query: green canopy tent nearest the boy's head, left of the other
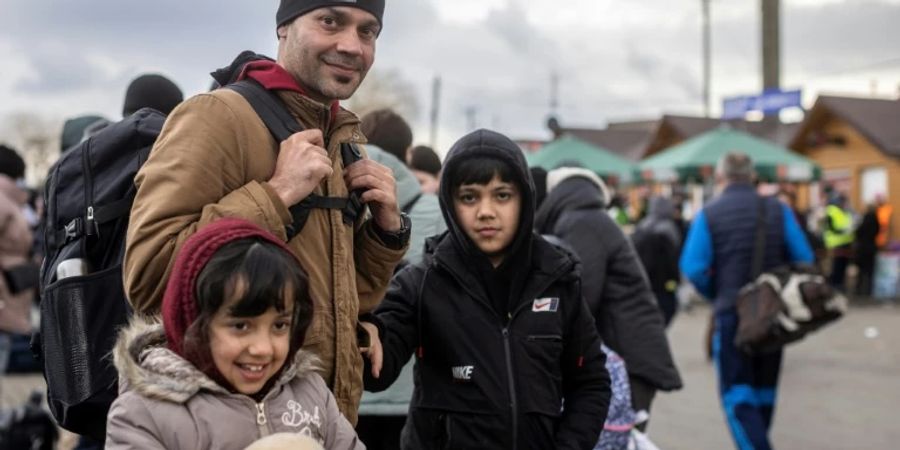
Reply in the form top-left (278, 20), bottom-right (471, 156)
top-left (526, 136), bottom-right (637, 184)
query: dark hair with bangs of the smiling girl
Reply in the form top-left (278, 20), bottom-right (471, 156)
top-left (184, 237), bottom-right (313, 378)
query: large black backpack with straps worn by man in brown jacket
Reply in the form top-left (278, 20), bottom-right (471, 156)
top-left (32, 60), bottom-right (364, 441)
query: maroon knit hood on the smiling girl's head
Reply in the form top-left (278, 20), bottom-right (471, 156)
top-left (162, 218), bottom-right (299, 356)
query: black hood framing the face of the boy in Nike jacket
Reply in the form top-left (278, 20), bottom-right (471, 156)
top-left (438, 126), bottom-right (535, 274)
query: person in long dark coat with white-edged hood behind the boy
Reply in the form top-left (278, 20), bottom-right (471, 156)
top-left (535, 168), bottom-right (681, 425)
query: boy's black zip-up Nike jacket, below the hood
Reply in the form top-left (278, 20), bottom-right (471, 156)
top-left (365, 234), bottom-right (610, 450)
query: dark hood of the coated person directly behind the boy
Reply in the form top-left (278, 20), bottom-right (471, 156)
top-left (534, 177), bottom-right (606, 234)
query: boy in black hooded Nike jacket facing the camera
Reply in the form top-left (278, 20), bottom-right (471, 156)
top-left (365, 130), bottom-right (610, 450)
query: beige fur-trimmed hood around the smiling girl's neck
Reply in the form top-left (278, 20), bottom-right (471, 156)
top-left (113, 316), bottom-right (318, 404)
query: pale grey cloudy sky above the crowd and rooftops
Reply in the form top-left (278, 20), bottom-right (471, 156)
top-left (0, 0), bottom-right (900, 150)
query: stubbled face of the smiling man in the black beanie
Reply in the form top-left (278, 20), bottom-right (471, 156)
top-left (278, 6), bottom-right (380, 104)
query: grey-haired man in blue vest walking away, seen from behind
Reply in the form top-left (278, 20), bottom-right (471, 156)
top-left (680, 152), bottom-right (813, 450)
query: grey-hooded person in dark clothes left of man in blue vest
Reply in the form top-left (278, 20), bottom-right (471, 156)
top-left (631, 197), bottom-right (681, 327)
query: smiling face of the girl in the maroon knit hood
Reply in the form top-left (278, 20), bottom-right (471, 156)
top-left (209, 283), bottom-right (293, 395)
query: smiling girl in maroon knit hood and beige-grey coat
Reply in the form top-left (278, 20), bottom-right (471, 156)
top-left (106, 219), bottom-right (365, 450)
